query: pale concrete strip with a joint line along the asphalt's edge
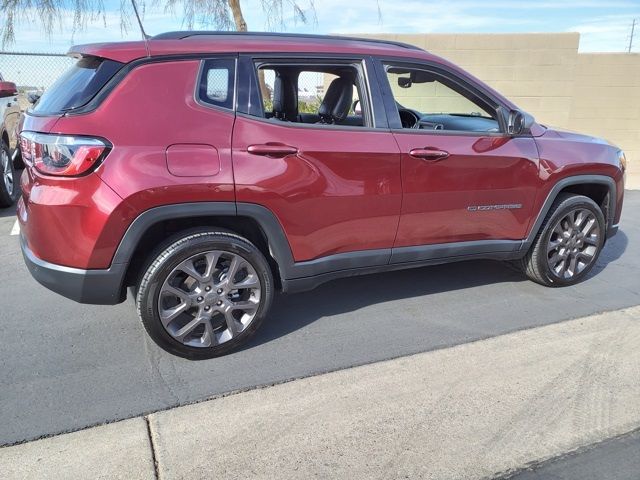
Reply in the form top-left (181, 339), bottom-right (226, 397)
top-left (0, 307), bottom-right (640, 479)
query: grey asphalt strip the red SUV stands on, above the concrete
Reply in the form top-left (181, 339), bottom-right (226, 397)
top-left (0, 191), bottom-right (640, 445)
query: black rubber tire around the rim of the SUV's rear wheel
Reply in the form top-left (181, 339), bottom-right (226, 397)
top-left (136, 230), bottom-right (274, 360)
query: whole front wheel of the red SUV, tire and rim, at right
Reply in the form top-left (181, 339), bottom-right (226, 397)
top-left (521, 194), bottom-right (606, 287)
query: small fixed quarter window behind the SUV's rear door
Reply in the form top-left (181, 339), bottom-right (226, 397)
top-left (198, 58), bottom-right (236, 109)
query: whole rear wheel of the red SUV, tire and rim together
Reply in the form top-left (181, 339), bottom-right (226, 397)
top-left (136, 231), bottom-right (273, 359)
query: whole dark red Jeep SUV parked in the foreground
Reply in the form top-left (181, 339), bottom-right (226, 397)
top-left (18, 32), bottom-right (625, 358)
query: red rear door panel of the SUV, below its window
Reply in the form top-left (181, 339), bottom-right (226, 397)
top-left (233, 116), bottom-right (402, 261)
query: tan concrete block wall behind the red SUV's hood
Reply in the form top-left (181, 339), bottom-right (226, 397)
top-left (358, 33), bottom-right (640, 184)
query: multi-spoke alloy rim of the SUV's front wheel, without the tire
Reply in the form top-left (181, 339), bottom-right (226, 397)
top-left (547, 208), bottom-right (601, 280)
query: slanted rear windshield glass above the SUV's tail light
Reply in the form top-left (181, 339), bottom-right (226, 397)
top-left (32, 57), bottom-right (124, 115)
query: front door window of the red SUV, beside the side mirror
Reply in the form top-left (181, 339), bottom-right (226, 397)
top-left (385, 65), bottom-right (500, 132)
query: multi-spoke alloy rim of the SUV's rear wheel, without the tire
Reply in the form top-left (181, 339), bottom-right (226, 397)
top-left (158, 250), bottom-right (261, 347)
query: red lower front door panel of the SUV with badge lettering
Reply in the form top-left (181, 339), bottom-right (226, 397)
top-left (394, 131), bottom-right (540, 247)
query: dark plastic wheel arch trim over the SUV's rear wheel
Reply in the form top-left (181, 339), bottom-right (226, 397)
top-left (118, 202), bottom-right (293, 288)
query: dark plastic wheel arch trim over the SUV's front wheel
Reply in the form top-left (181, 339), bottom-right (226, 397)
top-left (523, 175), bottom-right (617, 251)
